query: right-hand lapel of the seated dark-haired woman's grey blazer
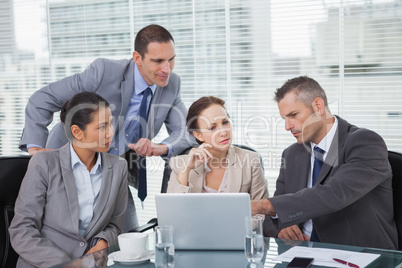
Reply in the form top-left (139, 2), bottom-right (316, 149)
top-left (85, 153), bottom-right (113, 236)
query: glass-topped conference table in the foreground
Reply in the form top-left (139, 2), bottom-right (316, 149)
top-left (55, 238), bottom-right (402, 268)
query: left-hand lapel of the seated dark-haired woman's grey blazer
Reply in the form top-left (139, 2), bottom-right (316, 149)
top-left (59, 143), bottom-right (79, 233)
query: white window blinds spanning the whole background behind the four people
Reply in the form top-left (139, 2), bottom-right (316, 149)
top-left (0, 0), bottom-right (402, 253)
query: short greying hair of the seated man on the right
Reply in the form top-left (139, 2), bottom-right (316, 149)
top-left (274, 76), bottom-right (328, 107)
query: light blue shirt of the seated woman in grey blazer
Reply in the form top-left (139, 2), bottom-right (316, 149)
top-left (70, 143), bottom-right (102, 235)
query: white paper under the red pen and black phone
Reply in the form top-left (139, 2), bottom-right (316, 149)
top-left (274, 246), bottom-right (380, 268)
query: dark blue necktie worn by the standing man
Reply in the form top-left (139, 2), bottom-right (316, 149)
top-left (137, 87), bottom-right (152, 201)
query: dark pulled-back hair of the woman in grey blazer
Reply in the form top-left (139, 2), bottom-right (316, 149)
top-left (60, 92), bottom-right (110, 141)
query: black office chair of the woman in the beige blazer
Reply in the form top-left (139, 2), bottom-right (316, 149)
top-left (129, 144), bottom-right (264, 232)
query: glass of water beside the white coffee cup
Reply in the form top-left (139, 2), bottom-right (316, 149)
top-left (155, 225), bottom-right (174, 268)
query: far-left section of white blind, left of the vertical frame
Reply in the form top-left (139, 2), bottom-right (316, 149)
top-left (0, 0), bottom-right (49, 155)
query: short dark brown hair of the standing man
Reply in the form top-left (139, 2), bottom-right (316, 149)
top-left (134, 24), bottom-right (174, 57)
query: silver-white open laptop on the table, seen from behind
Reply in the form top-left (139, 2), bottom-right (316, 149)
top-left (155, 193), bottom-right (251, 250)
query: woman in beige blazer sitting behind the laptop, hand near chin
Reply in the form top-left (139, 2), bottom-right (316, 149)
top-left (167, 96), bottom-right (268, 199)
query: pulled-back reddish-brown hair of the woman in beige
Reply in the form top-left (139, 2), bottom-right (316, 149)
top-left (186, 96), bottom-right (226, 144)
